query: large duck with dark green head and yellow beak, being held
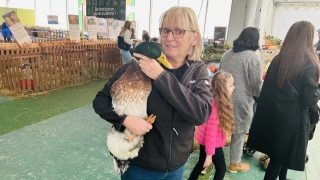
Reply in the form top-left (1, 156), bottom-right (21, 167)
top-left (107, 42), bottom-right (172, 174)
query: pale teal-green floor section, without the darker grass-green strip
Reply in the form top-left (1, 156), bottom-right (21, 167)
top-left (0, 104), bottom-right (314, 180)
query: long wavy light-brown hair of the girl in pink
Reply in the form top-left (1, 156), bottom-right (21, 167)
top-left (211, 70), bottom-right (235, 135)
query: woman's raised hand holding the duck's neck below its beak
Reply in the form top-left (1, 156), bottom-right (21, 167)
top-left (133, 53), bottom-right (164, 80)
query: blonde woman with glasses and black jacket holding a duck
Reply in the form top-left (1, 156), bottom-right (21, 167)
top-left (93, 7), bottom-right (212, 180)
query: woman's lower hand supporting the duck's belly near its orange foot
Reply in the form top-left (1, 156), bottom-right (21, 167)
top-left (122, 116), bottom-right (152, 136)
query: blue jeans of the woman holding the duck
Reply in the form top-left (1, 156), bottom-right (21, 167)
top-left (121, 165), bottom-right (184, 180)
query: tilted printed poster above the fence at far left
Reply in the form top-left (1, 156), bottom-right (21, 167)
top-left (2, 11), bottom-right (32, 47)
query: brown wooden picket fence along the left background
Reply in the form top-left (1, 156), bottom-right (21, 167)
top-left (0, 41), bottom-right (121, 94)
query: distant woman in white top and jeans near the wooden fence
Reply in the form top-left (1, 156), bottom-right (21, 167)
top-left (119, 21), bottom-right (133, 64)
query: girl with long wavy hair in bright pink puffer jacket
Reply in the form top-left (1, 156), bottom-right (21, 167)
top-left (189, 71), bottom-right (235, 180)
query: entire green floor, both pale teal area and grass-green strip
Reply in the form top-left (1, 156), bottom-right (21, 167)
top-left (0, 80), bottom-right (320, 180)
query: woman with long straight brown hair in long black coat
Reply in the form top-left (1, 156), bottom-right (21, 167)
top-left (247, 21), bottom-right (320, 180)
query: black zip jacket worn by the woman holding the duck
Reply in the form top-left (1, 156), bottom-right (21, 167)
top-left (93, 60), bottom-right (212, 171)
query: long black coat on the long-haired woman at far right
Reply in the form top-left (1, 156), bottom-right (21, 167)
top-left (247, 57), bottom-right (320, 171)
